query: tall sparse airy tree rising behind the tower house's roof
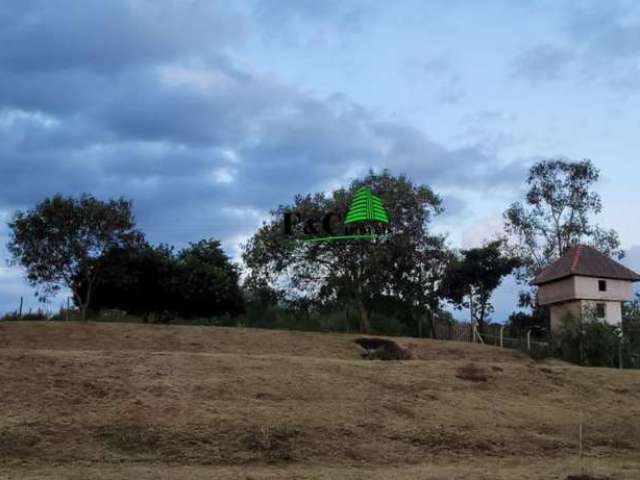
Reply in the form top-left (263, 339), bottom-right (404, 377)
top-left (504, 159), bottom-right (623, 306)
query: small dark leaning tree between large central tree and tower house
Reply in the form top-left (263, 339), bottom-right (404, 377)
top-left (442, 240), bottom-right (520, 332)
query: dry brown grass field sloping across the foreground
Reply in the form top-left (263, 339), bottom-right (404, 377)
top-left (0, 322), bottom-right (640, 480)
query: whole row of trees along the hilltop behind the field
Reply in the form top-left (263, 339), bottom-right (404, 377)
top-left (8, 159), bottom-right (622, 336)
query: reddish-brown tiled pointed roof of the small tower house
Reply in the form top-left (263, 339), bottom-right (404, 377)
top-left (531, 245), bottom-right (640, 285)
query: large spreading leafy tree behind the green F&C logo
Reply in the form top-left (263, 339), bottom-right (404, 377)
top-left (243, 171), bottom-right (441, 332)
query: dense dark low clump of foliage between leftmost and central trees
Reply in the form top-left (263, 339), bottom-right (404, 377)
top-left (74, 240), bottom-right (243, 325)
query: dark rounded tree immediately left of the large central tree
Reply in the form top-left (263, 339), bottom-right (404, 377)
top-left (177, 240), bottom-right (244, 317)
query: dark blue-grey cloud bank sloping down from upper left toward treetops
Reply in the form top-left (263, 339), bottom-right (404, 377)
top-left (0, 1), bottom-right (522, 309)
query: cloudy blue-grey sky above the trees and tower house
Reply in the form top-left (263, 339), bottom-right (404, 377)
top-left (0, 0), bottom-right (640, 321)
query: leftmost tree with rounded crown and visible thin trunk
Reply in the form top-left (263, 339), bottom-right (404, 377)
top-left (8, 194), bottom-right (141, 320)
